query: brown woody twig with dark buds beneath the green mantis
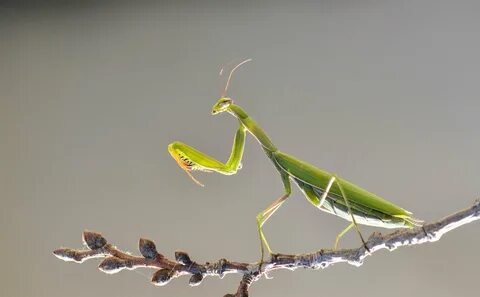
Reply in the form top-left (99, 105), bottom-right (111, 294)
top-left (53, 200), bottom-right (480, 297)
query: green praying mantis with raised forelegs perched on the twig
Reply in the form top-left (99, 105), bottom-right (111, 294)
top-left (168, 59), bottom-right (422, 262)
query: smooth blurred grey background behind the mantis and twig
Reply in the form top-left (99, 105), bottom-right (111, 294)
top-left (0, 0), bottom-right (480, 297)
